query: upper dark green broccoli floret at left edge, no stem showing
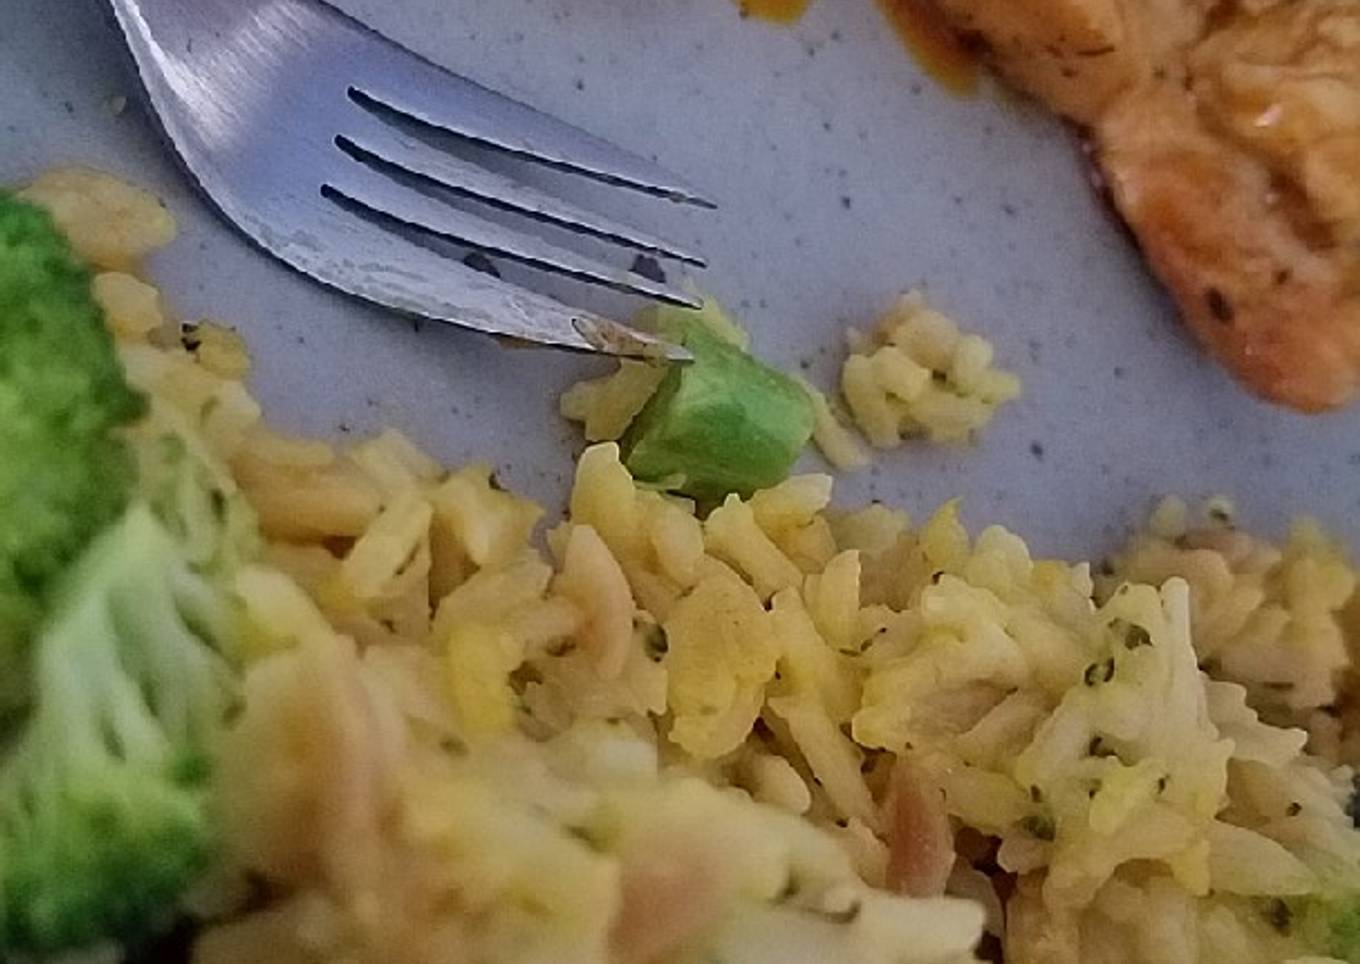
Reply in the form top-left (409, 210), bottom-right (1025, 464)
top-left (0, 192), bottom-right (144, 711)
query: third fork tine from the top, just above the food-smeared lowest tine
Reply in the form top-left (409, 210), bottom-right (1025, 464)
top-left (325, 162), bottom-right (702, 307)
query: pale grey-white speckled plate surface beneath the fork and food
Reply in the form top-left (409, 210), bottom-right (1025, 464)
top-left (0, 0), bottom-right (1360, 553)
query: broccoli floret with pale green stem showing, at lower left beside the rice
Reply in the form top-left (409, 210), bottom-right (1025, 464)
top-left (0, 503), bottom-right (237, 957)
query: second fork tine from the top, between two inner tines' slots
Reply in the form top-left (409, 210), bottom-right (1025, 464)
top-left (337, 111), bottom-right (704, 266)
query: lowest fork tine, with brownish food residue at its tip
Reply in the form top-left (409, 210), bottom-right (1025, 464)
top-left (294, 209), bottom-right (692, 362)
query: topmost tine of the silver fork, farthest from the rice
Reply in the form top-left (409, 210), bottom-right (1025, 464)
top-left (340, 22), bottom-right (715, 208)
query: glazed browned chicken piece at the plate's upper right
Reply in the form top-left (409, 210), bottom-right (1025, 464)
top-left (937, 0), bottom-right (1360, 412)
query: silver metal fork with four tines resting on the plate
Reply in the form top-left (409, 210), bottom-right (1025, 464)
top-left (109, 0), bottom-right (713, 360)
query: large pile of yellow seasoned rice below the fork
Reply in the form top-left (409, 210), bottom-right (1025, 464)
top-left (23, 165), bottom-right (1360, 964)
